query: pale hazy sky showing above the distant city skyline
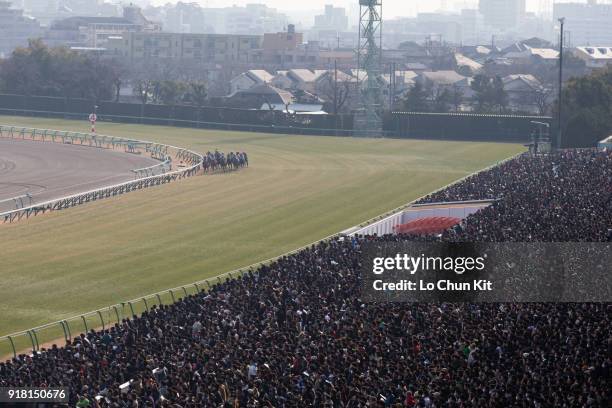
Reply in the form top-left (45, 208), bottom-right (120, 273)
top-left (153, 0), bottom-right (552, 17)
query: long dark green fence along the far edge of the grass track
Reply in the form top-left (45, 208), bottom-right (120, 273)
top-left (0, 94), bottom-right (552, 142)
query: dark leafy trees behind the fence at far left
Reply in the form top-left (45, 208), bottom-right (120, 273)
top-left (0, 39), bottom-right (208, 106)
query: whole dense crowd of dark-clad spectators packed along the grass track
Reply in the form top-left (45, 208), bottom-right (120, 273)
top-left (0, 152), bottom-right (612, 407)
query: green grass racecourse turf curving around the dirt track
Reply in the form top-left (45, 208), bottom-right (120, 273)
top-left (0, 116), bottom-right (523, 342)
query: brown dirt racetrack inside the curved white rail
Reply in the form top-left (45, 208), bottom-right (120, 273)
top-left (0, 139), bottom-right (159, 212)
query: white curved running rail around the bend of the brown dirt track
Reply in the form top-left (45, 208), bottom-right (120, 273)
top-left (0, 125), bottom-right (204, 223)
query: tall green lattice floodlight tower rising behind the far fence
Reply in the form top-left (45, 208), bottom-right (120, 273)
top-left (354, 0), bottom-right (382, 136)
